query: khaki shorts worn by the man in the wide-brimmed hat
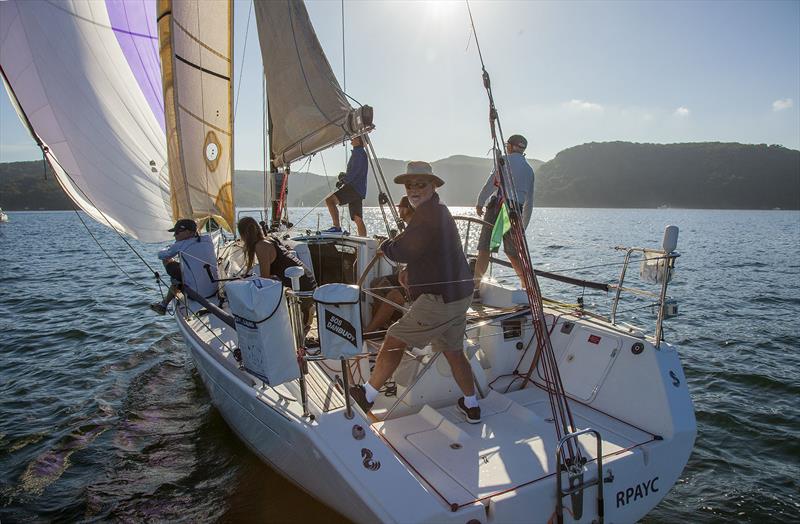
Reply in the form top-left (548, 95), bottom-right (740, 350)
top-left (386, 293), bottom-right (472, 351)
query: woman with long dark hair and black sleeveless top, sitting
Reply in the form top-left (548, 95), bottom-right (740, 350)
top-left (236, 217), bottom-right (317, 331)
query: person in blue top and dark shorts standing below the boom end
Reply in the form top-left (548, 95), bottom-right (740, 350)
top-left (325, 136), bottom-right (369, 237)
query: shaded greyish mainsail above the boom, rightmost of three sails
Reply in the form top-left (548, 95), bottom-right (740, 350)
top-left (255, 0), bottom-right (372, 167)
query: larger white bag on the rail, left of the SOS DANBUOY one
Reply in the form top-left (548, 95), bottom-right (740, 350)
top-left (225, 278), bottom-right (300, 386)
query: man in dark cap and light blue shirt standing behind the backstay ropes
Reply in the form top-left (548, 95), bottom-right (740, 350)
top-left (475, 135), bottom-right (534, 289)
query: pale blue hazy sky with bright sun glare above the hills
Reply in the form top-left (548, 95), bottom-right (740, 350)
top-left (0, 0), bottom-right (800, 175)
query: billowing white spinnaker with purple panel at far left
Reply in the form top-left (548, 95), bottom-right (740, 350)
top-left (0, 0), bottom-right (172, 242)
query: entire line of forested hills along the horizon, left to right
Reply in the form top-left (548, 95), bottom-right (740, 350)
top-left (0, 142), bottom-right (800, 210)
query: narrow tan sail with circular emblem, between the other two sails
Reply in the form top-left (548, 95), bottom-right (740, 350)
top-left (158, 0), bottom-right (234, 231)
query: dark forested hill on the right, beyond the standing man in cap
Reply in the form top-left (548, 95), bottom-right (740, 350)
top-left (536, 142), bottom-right (800, 209)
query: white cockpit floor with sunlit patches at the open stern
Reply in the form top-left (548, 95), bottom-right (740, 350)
top-left (373, 387), bottom-right (653, 506)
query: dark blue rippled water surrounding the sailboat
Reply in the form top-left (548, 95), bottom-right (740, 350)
top-left (0, 209), bottom-right (800, 523)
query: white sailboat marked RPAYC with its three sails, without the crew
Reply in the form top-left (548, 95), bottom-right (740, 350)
top-left (0, 0), bottom-right (696, 523)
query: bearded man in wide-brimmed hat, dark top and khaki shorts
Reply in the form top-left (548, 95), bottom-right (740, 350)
top-left (350, 161), bottom-right (481, 424)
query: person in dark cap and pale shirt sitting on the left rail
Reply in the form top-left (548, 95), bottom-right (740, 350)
top-left (150, 218), bottom-right (219, 315)
